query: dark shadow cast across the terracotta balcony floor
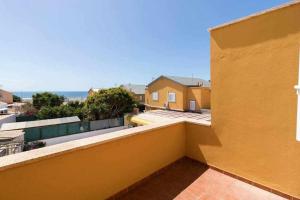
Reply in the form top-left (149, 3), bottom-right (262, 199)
top-left (118, 158), bottom-right (208, 200)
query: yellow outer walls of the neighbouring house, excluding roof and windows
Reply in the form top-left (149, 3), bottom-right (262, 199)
top-left (145, 78), bottom-right (210, 111)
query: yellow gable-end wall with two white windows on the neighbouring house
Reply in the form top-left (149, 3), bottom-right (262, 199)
top-left (145, 78), bottom-right (187, 111)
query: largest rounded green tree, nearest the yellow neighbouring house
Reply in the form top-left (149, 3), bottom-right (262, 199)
top-left (85, 87), bottom-right (136, 120)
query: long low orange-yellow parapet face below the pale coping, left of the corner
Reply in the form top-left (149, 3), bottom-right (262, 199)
top-left (0, 123), bottom-right (185, 200)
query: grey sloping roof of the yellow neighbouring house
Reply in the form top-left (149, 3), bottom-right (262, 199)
top-left (148, 76), bottom-right (210, 87)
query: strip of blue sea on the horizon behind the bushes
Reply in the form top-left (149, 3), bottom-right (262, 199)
top-left (13, 91), bottom-right (88, 101)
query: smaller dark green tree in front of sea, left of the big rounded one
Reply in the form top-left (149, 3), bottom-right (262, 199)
top-left (32, 92), bottom-right (65, 110)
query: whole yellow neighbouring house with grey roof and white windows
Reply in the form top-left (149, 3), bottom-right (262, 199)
top-left (145, 76), bottom-right (210, 112)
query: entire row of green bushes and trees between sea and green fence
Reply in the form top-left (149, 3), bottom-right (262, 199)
top-left (33, 87), bottom-right (137, 120)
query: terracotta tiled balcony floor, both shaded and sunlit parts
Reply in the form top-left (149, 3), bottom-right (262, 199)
top-left (118, 158), bottom-right (285, 200)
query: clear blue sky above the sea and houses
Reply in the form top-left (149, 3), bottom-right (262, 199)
top-left (0, 0), bottom-right (288, 91)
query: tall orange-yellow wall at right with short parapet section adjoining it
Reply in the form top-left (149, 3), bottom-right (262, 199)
top-left (187, 4), bottom-right (300, 197)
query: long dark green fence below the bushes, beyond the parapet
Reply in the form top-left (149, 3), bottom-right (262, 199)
top-left (24, 118), bottom-right (124, 142)
